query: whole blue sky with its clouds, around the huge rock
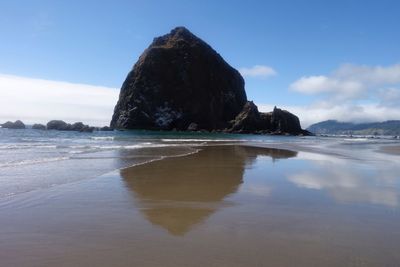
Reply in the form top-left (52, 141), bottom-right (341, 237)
top-left (0, 0), bottom-right (400, 127)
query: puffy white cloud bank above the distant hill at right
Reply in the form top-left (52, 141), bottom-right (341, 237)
top-left (259, 64), bottom-right (400, 127)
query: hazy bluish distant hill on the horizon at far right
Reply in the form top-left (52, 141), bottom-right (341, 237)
top-left (307, 120), bottom-right (400, 135)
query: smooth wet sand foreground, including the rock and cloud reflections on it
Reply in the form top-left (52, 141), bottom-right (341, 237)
top-left (0, 146), bottom-right (400, 267)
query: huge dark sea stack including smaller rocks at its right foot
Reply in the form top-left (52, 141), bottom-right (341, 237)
top-left (111, 27), bottom-right (305, 134)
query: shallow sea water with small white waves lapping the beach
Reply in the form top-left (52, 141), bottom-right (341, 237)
top-left (0, 128), bottom-right (399, 199)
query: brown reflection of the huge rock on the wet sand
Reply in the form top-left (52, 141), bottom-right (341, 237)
top-left (121, 146), bottom-right (296, 235)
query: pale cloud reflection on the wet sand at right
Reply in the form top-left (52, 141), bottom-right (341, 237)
top-left (288, 162), bottom-right (399, 207)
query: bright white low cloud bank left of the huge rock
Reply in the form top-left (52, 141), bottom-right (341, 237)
top-left (0, 74), bottom-right (119, 126)
